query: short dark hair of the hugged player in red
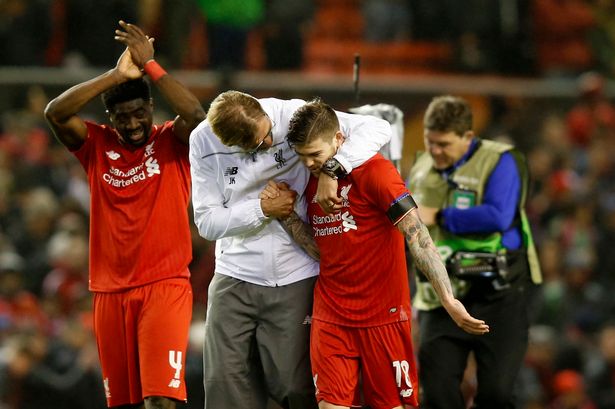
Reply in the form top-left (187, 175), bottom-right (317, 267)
top-left (286, 98), bottom-right (340, 147)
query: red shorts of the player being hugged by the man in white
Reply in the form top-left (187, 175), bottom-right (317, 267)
top-left (310, 320), bottom-right (419, 409)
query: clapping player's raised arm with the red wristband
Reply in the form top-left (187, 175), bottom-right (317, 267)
top-left (115, 21), bottom-right (205, 144)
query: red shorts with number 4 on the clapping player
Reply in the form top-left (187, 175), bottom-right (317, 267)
top-left (94, 278), bottom-right (192, 406)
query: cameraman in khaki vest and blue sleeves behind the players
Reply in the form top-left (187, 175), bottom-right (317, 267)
top-left (409, 95), bottom-right (541, 409)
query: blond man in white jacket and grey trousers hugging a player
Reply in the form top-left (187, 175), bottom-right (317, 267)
top-left (190, 91), bottom-right (391, 409)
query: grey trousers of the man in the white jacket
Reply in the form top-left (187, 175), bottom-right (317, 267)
top-left (203, 274), bottom-right (318, 409)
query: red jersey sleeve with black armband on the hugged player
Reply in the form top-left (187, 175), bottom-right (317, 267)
top-left (364, 155), bottom-right (417, 224)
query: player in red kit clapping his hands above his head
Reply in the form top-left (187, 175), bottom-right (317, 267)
top-left (45, 21), bottom-right (205, 409)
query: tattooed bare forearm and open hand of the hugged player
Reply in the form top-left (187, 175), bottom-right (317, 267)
top-left (397, 208), bottom-right (489, 335)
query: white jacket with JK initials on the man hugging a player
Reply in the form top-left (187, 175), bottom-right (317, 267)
top-left (190, 98), bottom-right (391, 286)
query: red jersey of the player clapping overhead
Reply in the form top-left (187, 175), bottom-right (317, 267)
top-left (74, 121), bottom-right (192, 292)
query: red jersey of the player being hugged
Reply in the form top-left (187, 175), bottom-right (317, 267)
top-left (306, 155), bottom-right (411, 327)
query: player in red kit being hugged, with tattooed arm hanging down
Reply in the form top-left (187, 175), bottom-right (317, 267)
top-left (262, 100), bottom-right (489, 409)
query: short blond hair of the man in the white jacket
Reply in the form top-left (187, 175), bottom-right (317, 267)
top-left (207, 91), bottom-right (266, 149)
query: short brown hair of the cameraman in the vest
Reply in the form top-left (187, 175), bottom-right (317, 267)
top-left (423, 95), bottom-right (472, 136)
